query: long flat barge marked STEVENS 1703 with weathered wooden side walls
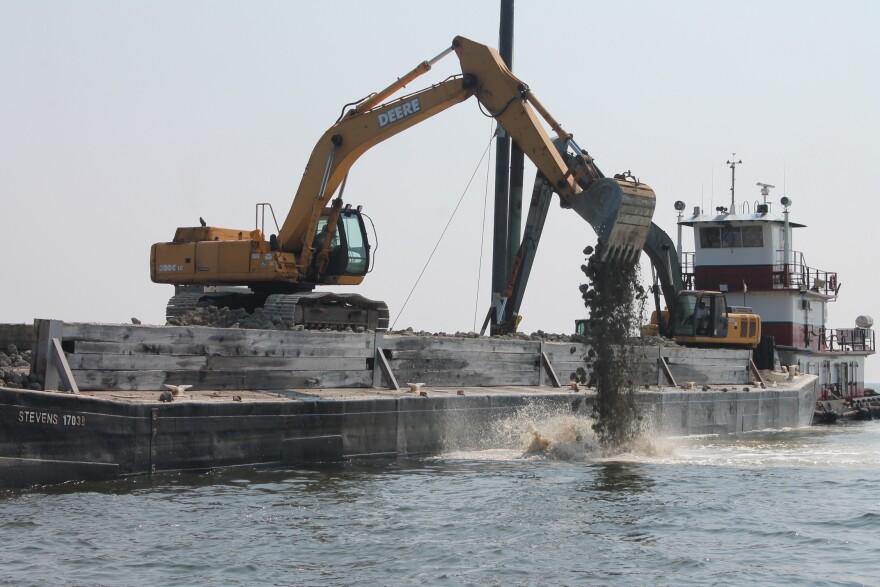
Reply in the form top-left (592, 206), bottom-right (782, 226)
top-left (0, 321), bottom-right (818, 486)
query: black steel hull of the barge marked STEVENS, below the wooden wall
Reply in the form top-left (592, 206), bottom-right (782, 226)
top-left (0, 375), bottom-right (818, 487)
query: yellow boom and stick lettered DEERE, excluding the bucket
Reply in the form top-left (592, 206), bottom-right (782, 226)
top-left (278, 36), bottom-right (636, 272)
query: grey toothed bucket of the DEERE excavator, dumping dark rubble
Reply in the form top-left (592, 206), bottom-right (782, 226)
top-left (566, 177), bottom-right (656, 263)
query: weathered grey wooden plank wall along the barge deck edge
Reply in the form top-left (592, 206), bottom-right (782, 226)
top-left (27, 320), bottom-right (750, 391)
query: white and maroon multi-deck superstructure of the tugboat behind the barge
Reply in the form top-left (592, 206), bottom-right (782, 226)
top-left (678, 184), bottom-right (876, 400)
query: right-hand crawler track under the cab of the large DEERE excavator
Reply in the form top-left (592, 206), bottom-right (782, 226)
top-left (263, 292), bottom-right (389, 330)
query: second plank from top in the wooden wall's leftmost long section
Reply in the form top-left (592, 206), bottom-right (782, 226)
top-left (72, 340), bottom-right (373, 359)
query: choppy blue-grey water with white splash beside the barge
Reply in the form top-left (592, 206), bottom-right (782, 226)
top-left (0, 406), bottom-right (880, 586)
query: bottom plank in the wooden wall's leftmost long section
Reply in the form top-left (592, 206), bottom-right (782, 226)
top-left (73, 370), bottom-right (372, 397)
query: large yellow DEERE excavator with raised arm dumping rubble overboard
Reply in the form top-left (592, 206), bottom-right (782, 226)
top-left (150, 36), bottom-right (655, 330)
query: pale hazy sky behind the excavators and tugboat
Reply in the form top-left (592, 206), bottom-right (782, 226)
top-left (0, 0), bottom-right (880, 381)
